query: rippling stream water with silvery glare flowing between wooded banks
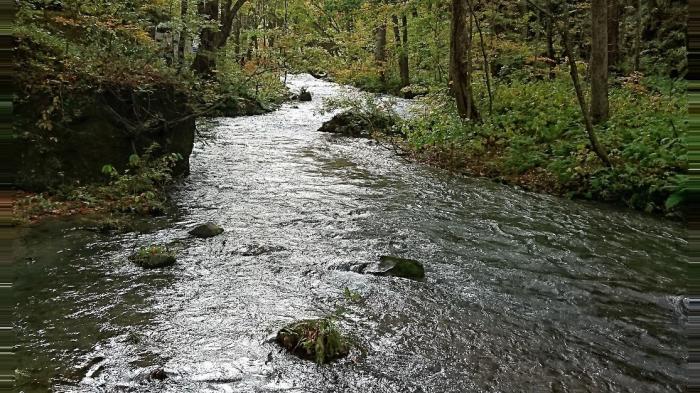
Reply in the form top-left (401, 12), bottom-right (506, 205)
top-left (15, 75), bottom-right (688, 393)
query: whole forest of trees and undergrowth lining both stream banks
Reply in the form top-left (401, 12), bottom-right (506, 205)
top-left (16, 0), bottom-right (687, 215)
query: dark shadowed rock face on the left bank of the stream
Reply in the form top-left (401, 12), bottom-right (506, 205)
top-left (15, 86), bottom-right (195, 191)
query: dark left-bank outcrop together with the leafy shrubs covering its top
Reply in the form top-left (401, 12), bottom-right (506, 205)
top-left (15, 5), bottom-right (202, 190)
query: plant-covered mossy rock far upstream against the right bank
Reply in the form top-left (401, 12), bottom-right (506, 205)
top-left (319, 110), bottom-right (395, 138)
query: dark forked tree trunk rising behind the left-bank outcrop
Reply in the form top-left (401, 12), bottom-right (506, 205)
top-left (192, 0), bottom-right (247, 75)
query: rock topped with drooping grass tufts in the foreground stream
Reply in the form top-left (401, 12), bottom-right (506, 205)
top-left (276, 318), bottom-right (350, 364)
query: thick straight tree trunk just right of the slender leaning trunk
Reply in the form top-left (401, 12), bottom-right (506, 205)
top-left (590, 0), bottom-right (609, 124)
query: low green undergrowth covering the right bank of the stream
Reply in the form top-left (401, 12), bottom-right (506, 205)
top-left (402, 71), bottom-right (687, 212)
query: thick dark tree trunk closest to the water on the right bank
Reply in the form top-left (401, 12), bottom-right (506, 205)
top-left (450, 0), bottom-right (479, 121)
